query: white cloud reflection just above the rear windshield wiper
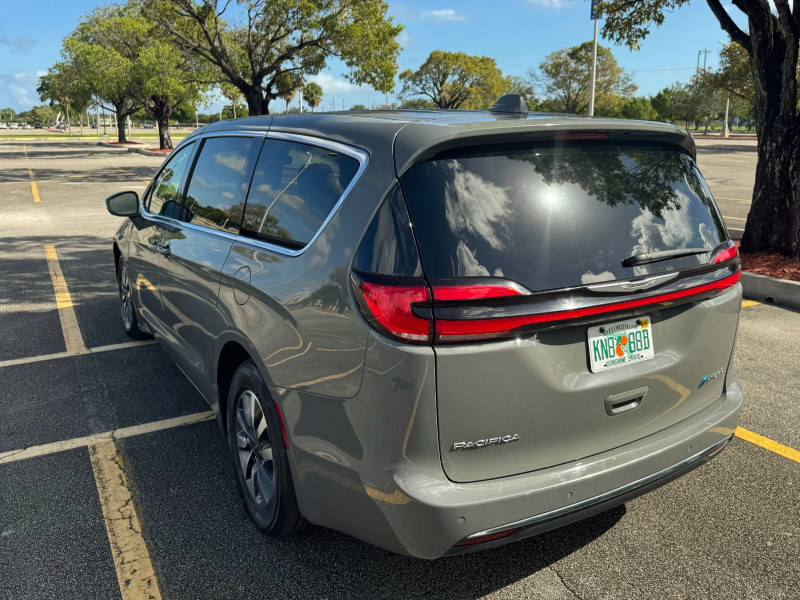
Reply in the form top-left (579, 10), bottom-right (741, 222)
top-left (631, 190), bottom-right (694, 255)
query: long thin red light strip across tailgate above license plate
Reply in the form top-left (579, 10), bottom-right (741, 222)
top-left (435, 271), bottom-right (742, 342)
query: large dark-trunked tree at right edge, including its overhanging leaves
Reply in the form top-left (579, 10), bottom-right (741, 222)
top-left (600, 0), bottom-right (800, 258)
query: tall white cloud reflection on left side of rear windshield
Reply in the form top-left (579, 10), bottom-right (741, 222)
top-left (445, 161), bottom-right (510, 250)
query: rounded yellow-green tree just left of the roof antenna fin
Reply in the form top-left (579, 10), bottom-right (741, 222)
top-left (400, 50), bottom-right (511, 108)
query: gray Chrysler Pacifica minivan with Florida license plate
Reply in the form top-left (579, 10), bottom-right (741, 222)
top-left (107, 98), bottom-right (742, 558)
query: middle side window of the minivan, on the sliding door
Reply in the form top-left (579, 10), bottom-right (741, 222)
top-left (184, 137), bottom-right (260, 233)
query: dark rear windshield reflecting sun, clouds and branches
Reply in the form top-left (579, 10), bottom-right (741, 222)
top-left (401, 144), bottom-right (728, 291)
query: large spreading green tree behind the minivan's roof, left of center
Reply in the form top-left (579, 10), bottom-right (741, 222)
top-left (143, 0), bottom-right (402, 115)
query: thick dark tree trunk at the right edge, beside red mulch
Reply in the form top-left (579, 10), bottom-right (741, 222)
top-left (741, 7), bottom-right (800, 259)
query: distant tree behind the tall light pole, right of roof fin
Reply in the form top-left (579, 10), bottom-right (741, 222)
top-left (528, 42), bottom-right (636, 114)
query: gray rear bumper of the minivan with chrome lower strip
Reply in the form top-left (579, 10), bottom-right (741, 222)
top-left (294, 382), bottom-right (742, 559)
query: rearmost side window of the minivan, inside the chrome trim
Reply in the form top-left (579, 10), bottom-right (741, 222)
top-left (242, 140), bottom-right (358, 248)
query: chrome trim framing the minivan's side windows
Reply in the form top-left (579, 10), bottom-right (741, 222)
top-left (140, 131), bottom-right (369, 256)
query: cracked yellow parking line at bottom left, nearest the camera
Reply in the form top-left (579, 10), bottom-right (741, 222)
top-left (89, 440), bottom-right (161, 600)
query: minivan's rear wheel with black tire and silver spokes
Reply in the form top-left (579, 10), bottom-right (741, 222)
top-left (227, 360), bottom-right (307, 538)
